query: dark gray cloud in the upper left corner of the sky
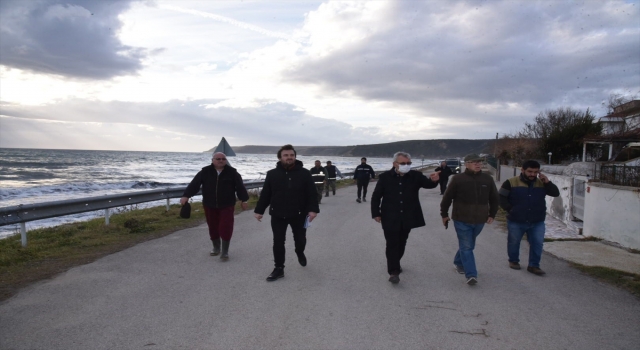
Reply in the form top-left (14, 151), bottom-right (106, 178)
top-left (0, 0), bottom-right (147, 79)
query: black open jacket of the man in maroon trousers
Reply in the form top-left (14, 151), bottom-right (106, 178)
top-left (182, 165), bottom-right (249, 208)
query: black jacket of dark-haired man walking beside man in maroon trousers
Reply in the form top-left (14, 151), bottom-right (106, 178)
top-left (254, 160), bottom-right (320, 218)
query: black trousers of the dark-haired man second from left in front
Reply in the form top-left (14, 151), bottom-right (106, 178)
top-left (271, 214), bottom-right (307, 267)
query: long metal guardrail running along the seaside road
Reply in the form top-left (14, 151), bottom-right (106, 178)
top-left (0, 164), bottom-right (432, 246)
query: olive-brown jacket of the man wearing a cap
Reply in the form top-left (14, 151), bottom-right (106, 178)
top-left (440, 169), bottom-right (500, 224)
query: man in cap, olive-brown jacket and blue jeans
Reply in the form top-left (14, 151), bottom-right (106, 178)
top-left (440, 154), bottom-right (498, 285)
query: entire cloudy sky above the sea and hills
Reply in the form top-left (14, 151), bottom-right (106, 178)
top-left (0, 0), bottom-right (640, 152)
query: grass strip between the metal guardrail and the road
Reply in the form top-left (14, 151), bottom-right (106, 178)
top-left (0, 196), bottom-right (257, 301)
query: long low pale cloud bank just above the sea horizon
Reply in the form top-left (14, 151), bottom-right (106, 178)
top-left (0, 99), bottom-right (384, 151)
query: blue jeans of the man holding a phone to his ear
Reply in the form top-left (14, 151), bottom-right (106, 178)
top-left (507, 220), bottom-right (545, 267)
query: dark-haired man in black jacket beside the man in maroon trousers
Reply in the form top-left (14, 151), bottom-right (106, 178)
top-left (254, 145), bottom-right (320, 281)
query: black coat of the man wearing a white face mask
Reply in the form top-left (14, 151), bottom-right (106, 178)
top-left (371, 168), bottom-right (438, 231)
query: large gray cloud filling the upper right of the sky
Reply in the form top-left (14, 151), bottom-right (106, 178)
top-left (288, 1), bottom-right (640, 119)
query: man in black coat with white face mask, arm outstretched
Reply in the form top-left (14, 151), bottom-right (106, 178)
top-left (371, 152), bottom-right (438, 284)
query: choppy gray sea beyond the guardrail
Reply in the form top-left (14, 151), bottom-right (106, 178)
top-left (0, 148), bottom-right (437, 238)
